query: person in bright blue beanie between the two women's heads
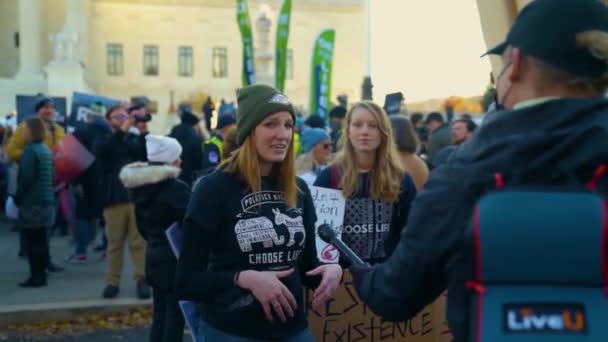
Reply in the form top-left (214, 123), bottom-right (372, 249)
top-left (296, 128), bottom-right (333, 185)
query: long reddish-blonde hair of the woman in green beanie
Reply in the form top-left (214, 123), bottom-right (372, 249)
top-left (226, 130), bottom-right (300, 208)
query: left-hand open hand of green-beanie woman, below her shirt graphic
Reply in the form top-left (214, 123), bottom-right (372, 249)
top-left (237, 268), bottom-right (298, 322)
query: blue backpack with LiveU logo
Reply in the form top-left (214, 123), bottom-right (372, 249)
top-left (466, 167), bottom-right (608, 342)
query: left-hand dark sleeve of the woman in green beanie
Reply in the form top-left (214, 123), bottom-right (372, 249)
top-left (176, 177), bottom-right (237, 301)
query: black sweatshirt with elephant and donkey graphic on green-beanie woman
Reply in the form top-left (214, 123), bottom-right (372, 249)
top-left (176, 171), bottom-right (320, 340)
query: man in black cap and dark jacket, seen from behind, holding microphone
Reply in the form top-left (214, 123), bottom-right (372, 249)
top-left (350, 0), bottom-right (608, 342)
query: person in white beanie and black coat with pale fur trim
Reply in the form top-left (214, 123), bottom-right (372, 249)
top-left (120, 134), bottom-right (190, 342)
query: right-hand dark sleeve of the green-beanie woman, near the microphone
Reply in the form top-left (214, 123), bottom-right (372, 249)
top-left (298, 181), bottom-right (321, 289)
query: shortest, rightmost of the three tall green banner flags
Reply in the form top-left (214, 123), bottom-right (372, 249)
top-left (310, 29), bottom-right (336, 119)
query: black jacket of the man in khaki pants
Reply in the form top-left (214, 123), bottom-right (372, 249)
top-left (93, 130), bottom-right (143, 208)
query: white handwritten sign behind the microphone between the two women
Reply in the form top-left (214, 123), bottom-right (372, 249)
top-left (310, 186), bottom-right (346, 263)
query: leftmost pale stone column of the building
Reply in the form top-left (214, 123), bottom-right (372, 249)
top-left (17, 0), bottom-right (42, 80)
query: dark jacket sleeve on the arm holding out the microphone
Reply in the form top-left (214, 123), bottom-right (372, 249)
top-left (351, 166), bottom-right (475, 321)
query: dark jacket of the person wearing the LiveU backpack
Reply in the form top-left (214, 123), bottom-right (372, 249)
top-left (353, 98), bottom-right (608, 341)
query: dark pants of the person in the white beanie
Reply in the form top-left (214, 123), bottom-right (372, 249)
top-left (150, 287), bottom-right (184, 342)
